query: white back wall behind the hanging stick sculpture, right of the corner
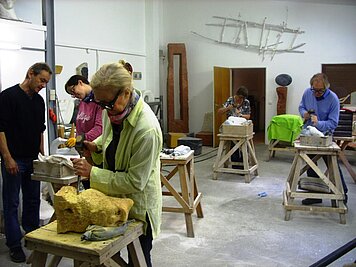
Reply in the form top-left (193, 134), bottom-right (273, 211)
top-left (161, 0), bottom-right (356, 141)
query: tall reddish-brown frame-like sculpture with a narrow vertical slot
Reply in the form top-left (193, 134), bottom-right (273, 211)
top-left (167, 43), bottom-right (189, 133)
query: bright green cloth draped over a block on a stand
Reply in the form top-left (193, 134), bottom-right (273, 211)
top-left (267, 114), bottom-right (303, 144)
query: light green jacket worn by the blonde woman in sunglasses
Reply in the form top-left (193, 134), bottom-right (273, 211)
top-left (90, 91), bottom-right (163, 238)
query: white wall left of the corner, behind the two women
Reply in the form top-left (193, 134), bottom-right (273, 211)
top-left (15, 0), bottom-right (154, 124)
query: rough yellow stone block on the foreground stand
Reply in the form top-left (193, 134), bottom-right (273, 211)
top-left (53, 186), bottom-right (134, 233)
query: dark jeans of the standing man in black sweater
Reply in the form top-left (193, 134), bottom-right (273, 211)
top-left (1, 159), bottom-right (41, 249)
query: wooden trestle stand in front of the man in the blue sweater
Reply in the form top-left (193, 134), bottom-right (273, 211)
top-left (283, 141), bottom-right (347, 224)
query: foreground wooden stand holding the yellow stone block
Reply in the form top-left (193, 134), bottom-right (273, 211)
top-left (25, 221), bottom-right (147, 267)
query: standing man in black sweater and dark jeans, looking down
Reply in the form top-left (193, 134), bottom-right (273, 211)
top-left (0, 63), bottom-right (52, 262)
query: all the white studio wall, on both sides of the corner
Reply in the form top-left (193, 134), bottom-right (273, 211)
top-left (10, 0), bottom-right (356, 143)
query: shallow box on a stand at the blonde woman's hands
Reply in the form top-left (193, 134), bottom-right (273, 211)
top-left (33, 160), bottom-right (75, 178)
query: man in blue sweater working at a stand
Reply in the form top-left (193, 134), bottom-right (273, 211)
top-left (299, 73), bottom-right (347, 205)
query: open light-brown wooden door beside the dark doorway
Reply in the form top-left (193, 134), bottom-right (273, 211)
top-left (213, 67), bottom-right (231, 147)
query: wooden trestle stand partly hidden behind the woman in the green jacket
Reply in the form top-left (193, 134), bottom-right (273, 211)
top-left (161, 150), bottom-right (204, 237)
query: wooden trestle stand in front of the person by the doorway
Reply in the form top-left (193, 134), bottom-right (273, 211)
top-left (213, 134), bottom-right (258, 183)
